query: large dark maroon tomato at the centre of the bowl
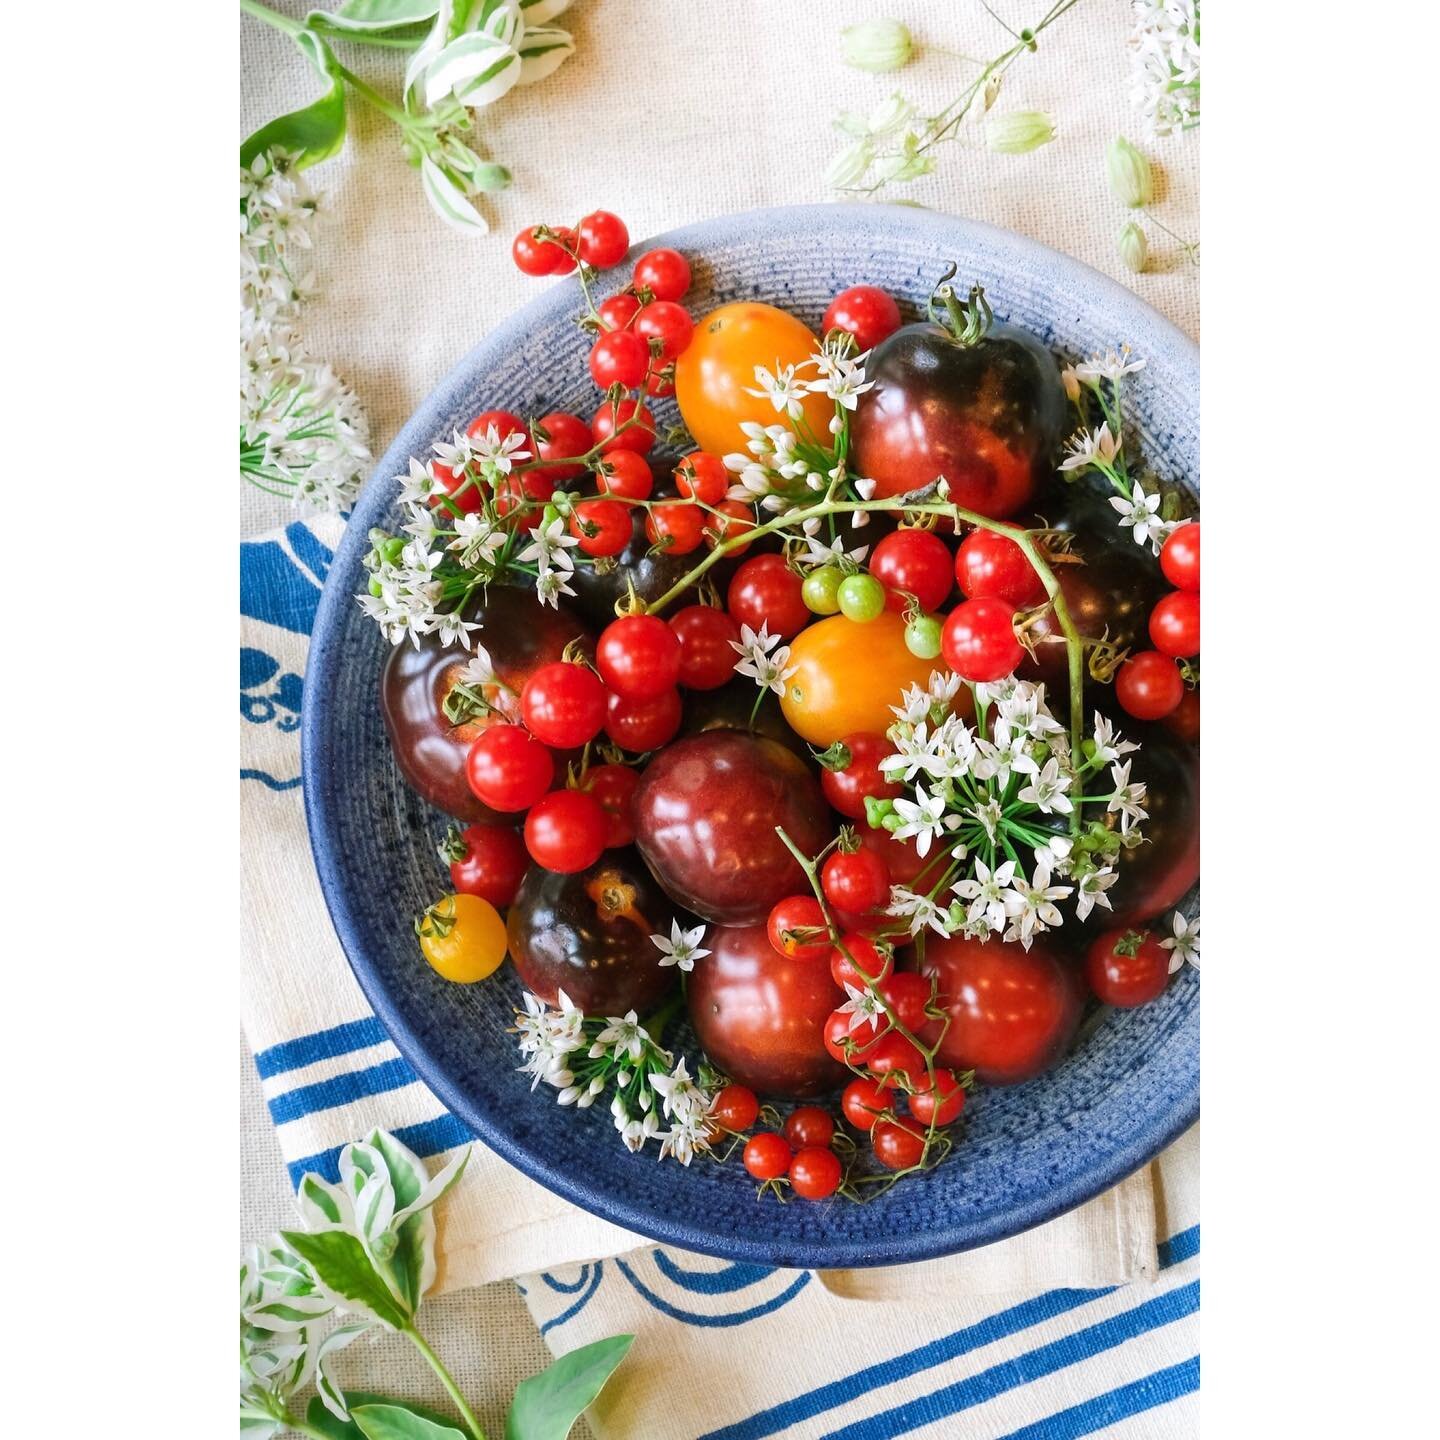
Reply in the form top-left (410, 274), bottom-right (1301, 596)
top-left (634, 730), bottom-right (831, 924)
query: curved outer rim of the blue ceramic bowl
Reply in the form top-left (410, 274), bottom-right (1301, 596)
top-left (301, 202), bottom-right (1200, 1269)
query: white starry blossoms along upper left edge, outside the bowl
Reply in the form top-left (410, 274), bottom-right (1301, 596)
top-left (240, 150), bottom-right (370, 511)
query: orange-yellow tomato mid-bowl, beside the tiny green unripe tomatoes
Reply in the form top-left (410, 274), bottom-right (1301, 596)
top-left (780, 611), bottom-right (936, 746)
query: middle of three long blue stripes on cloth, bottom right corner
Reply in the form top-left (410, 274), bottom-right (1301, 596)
top-left (824, 1280), bottom-right (1200, 1440)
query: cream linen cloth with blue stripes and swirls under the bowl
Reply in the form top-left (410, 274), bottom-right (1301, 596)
top-left (240, 518), bottom-right (1200, 1440)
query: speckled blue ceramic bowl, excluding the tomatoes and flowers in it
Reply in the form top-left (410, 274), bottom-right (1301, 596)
top-left (302, 204), bottom-right (1200, 1267)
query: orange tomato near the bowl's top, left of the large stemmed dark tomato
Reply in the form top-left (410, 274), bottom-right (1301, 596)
top-left (675, 300), bottom-right (835, 455)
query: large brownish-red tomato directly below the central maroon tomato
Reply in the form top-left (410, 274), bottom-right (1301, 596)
top-left (688, 924), bottom-right (845, 1100)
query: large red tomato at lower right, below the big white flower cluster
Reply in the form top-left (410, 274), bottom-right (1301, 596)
top-left (920, 935), bottom-right (1081, 1084)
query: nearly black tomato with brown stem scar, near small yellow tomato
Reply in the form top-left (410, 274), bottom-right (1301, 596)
top-left (507, 848), bottom-right (677, 1015)
